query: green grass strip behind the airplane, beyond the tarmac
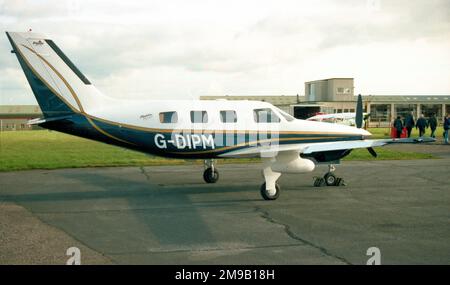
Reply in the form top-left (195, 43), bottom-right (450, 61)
top-left (0, 129), bottom-right (436, 171)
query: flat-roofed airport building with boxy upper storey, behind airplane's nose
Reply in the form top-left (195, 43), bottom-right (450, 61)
top-left (201, 78), bottom-right (450, 127)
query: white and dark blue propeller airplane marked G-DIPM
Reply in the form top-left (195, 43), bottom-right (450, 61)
top-left (6, 32), bottom-right (433, 200)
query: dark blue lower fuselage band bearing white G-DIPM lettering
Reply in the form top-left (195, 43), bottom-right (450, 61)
top-left (37, 114), bottom-right (362, 158)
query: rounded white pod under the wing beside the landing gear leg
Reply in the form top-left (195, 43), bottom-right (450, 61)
top-left (270, 152), bottom-right (316, 173)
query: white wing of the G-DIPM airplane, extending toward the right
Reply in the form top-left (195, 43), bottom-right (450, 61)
top-left (219, 138), bottom-right (436, 157)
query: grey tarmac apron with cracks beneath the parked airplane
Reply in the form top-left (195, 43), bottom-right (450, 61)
top-left (0, 146), bottom-right (450, 264)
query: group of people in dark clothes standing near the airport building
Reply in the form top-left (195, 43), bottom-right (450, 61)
top-left (393, 112), bottom-right (450, 144)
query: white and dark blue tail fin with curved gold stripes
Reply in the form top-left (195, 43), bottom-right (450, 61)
top-left (6, 32), bottom-right (102, 117)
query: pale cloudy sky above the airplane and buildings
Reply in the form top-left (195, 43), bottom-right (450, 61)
top-left (0, 0), bottom-right (450, 104)
